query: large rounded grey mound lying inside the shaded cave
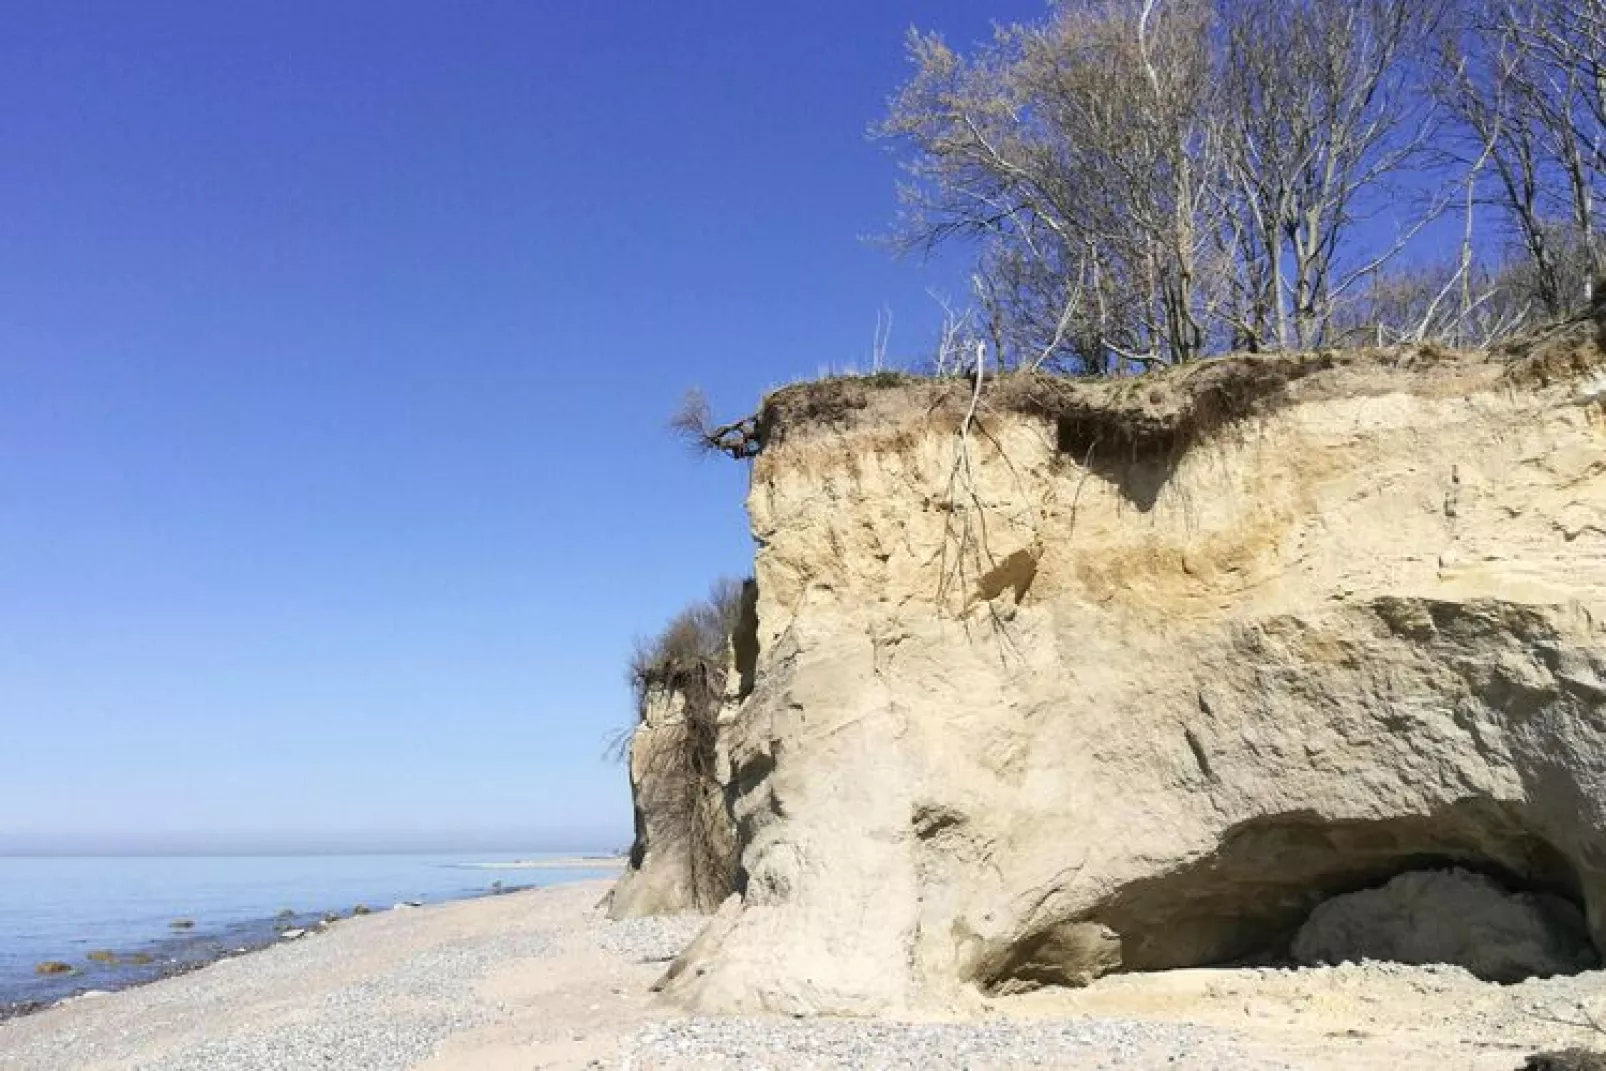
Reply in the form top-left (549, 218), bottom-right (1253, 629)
top-left (1293, 870), bottom-right (1596, 983)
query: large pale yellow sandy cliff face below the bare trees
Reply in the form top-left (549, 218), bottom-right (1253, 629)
top-left (665, 339), bottom-right (1606, 1015)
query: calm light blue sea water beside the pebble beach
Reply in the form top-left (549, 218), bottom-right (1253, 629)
top-left (0, 854), bottom-right (615, 1010)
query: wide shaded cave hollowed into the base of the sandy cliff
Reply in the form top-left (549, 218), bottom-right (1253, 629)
top-left (978, 800), bottom-right (1600, 992)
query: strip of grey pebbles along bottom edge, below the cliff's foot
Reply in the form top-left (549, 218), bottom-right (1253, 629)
top-left (620, 1020), bottom-right (1293, 1071)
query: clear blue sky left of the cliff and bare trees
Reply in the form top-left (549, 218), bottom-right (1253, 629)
top-left (0, 0), bottom-right (1042, 851)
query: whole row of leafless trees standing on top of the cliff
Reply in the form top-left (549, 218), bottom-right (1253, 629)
top-left (878, 0), bottom-right (1606, 374)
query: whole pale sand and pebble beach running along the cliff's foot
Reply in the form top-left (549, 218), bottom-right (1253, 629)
top-left (0, 882), bottom-right (1606, 1071)
